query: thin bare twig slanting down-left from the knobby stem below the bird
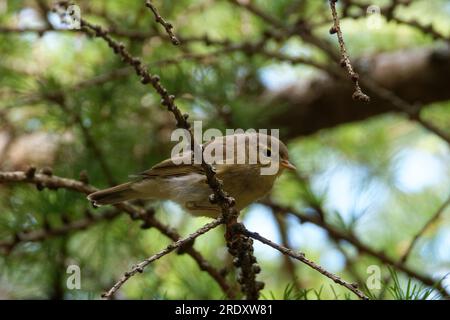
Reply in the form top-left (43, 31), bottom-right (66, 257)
top-left (102, 217), bottom-right (223, 299)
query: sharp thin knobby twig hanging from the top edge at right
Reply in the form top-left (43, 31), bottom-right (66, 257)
top-left (329, 0), bottom-right (370, 102)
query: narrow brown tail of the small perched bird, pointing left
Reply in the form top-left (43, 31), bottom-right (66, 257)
top-left (87, 182), bottom-right (140, 206)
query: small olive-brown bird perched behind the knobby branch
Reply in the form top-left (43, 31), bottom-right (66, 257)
top-left (88, 133), bottom-right (296, 217)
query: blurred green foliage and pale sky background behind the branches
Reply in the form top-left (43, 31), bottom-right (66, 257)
top-left (0, 0), bottom-right (450, 299)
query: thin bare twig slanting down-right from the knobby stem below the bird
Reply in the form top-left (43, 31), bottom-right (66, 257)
top-left (242, 226), bottom-right (369, 300)
